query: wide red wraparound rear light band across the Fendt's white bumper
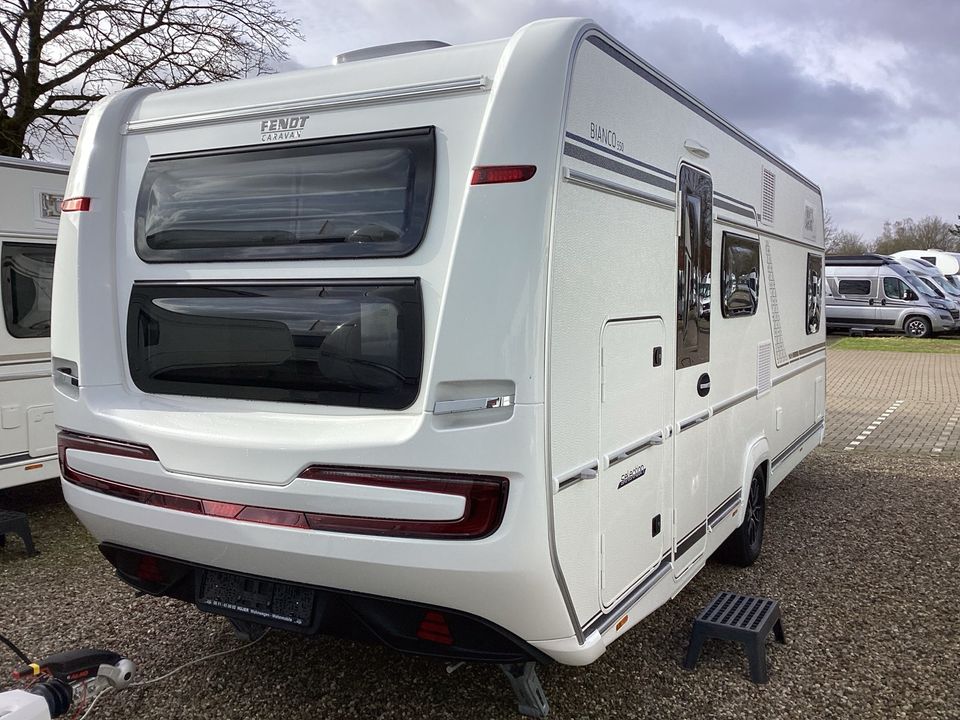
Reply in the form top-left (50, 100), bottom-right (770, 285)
top-left (58, 431), bottom-right (508, 540)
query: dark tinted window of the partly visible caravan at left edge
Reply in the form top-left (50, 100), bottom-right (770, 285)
top-left (0, 242), bottom-right (55, 338)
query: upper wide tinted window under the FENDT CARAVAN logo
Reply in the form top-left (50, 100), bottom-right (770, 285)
top-left (135, 128), bottom-right (436, 262)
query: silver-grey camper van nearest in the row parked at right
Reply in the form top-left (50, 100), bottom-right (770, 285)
top-left (826, 254), bottom-right (960, 337)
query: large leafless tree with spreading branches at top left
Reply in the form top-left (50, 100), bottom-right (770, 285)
top-left (0, 0), bottom-right (300, 157)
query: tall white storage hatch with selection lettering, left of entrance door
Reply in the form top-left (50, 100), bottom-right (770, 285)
top-left (599, 318), bottom-right (669, 608)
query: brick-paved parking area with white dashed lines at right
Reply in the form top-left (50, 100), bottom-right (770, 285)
top-left (824, 347), bottom-right (960, 457)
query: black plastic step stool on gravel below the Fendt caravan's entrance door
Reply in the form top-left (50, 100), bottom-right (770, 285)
top-left (683, 592), bottom-right (787, 683)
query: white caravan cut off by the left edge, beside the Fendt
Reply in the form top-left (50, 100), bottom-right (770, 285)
top-left (0, 157), bottom-right (67, 490)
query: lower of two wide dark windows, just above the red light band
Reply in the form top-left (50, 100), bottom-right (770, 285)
top-left (127, 280), bottom-right (423, 410)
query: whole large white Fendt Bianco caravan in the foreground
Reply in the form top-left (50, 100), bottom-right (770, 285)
top-left (53, 19), bottom-right (825, 714)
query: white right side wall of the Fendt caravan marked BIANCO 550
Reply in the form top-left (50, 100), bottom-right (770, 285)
top-left (548, 29), bottom-right (825, 644)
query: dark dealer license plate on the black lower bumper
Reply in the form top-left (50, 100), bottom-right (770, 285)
top-left (197, 570), bottom-right (316, 628)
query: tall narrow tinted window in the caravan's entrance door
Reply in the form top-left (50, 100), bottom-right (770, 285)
top-left (677, 165), bottom-right (713, 368)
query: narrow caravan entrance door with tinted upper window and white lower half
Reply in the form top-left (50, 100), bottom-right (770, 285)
top-left (673, 165), bottom-right (713, 576)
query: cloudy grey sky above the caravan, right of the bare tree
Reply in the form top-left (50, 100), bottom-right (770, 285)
top-left (277, 0), bottom-right (960, 240)
